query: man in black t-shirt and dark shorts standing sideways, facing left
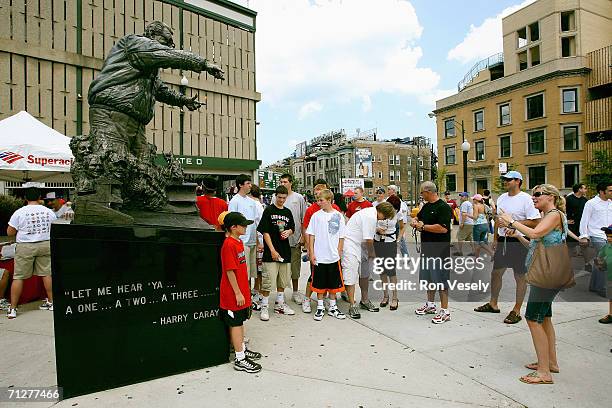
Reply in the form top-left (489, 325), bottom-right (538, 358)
top-left (410, 181), bottom-right (452, 324)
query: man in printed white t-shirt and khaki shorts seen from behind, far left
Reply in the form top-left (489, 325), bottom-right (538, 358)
top-left (6, 183), bottom-right (56, 319)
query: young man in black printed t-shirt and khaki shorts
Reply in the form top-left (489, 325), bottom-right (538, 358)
top-left (257, 186), bottom-right (295, 321)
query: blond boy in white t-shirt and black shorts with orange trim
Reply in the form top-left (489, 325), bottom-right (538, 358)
top-left (306, 190), bottom-right (346, 321)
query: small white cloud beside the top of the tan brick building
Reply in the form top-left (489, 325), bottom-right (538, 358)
top-left (447, 0), bottom-right (536, 64)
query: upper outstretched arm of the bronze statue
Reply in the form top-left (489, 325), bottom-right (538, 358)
top-left (125, 37), bottom-right (223, 79)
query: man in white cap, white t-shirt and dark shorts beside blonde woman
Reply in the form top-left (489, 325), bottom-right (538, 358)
top-left (474, 171), bottom-right (540, 324)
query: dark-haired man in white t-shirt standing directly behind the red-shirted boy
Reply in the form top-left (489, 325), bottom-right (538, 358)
top-left (228, 174), bottom-right (261, 296)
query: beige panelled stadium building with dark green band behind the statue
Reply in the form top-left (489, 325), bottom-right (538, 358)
top-left (0, 0), bottom-right (261, 191)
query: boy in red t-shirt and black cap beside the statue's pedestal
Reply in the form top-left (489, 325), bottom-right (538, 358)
top-left (219, 212), bottom-right (261, 373)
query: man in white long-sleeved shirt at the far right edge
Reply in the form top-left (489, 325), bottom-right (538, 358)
top-left (580, 181), bottom-right (612, 296)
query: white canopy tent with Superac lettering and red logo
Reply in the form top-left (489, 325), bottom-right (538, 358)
top-left (0, 111), bottom-right (74, 183)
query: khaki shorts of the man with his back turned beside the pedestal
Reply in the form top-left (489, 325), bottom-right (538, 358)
top-left (13, 241), bottom-right (51, 279)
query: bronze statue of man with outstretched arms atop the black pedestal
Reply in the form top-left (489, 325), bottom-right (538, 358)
top-left (70, 21), bottom-right (224, 223)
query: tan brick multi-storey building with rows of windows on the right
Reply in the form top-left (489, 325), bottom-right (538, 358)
top-left (433, 0), bottom-right (612, 193)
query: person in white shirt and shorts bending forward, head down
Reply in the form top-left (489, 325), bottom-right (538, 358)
top-left (342, 201), bottom-right (395, 319)
